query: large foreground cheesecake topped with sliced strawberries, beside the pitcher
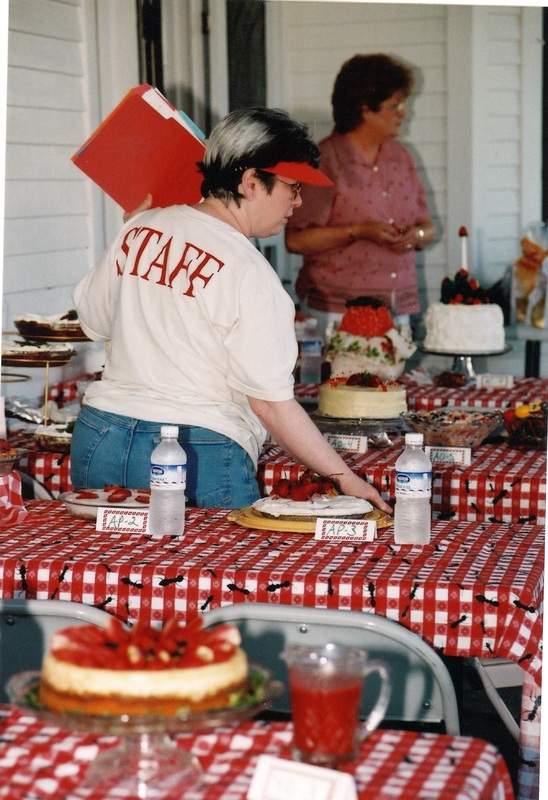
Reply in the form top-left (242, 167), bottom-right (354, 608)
top-left (39, 617), bottom-right (249, 716)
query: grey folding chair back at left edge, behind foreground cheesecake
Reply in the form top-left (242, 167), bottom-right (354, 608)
top-left (0, 599), bottom-right (111, 703)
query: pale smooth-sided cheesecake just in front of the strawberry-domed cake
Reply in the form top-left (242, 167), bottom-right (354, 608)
top-left (318, 372), bottom-right (407, 419)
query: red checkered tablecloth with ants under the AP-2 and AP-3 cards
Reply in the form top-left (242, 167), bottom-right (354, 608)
top-left (0, 501), bottom-right (544, 798)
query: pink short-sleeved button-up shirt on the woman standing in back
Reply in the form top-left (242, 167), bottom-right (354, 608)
top-left (288, 132), bottom-right (430, 314)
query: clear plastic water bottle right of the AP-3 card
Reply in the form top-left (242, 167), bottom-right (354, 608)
top-left (394, 433), bottom-right (432, 544)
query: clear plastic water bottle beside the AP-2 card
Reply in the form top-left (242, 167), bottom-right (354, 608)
top-left (148, 425), bottom-right (186, 536)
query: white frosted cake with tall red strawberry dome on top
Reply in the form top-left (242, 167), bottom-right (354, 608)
top-left (326, 297), bottom-right (416, 380)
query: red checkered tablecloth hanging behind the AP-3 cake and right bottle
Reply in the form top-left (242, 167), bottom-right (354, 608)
top-left (258, 437), bottom-right (546, 524)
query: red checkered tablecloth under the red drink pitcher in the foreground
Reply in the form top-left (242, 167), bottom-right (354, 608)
top-left (0, 706), bottom-right (514, 800)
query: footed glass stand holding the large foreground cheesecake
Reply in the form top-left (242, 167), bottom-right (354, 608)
top-left (7, 665), bottom-right (283, 800)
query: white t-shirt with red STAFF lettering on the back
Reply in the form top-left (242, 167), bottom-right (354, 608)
top-left (73, 206), bottom-right (297, 463)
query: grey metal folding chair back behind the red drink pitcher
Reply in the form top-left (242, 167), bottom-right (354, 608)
top-left (203, 603), bottom-right (460, 736)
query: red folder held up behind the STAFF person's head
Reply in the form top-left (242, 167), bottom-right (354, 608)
top-left (72, 83), bottom-right (205, 211)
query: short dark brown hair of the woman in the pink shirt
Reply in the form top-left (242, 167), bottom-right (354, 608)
top-left (331, 53), bottom-right (413, 133)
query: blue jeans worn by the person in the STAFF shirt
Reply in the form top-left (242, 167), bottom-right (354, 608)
top-left (70, 406), bottom-right (260, 508)
